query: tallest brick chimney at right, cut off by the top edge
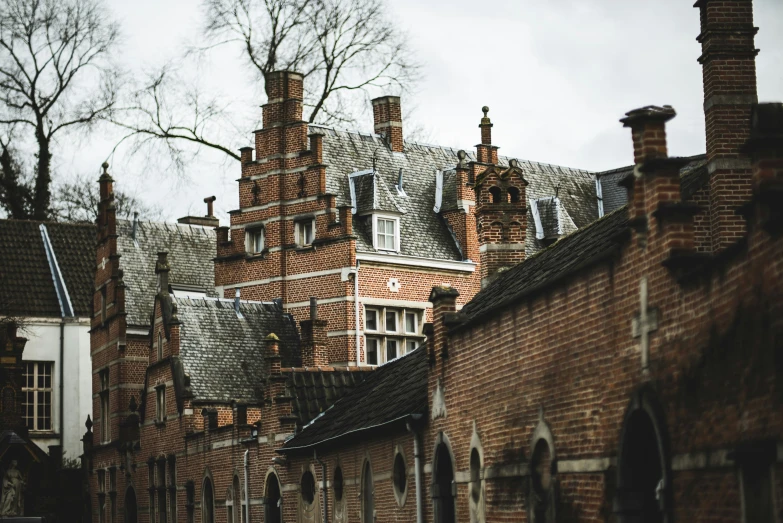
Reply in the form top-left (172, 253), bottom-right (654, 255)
top-left (694, 0), bottom-right (758, 252)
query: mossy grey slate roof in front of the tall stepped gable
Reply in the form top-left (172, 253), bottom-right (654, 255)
top-left (172, 297), bottom-right (301, 402)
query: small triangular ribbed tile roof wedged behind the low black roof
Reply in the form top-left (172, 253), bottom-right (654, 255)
top-left (284, 367), bottom-right (374, 427)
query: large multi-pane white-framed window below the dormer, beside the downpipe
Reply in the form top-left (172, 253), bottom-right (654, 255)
top-left (364, 307), bottom-right (424, 365)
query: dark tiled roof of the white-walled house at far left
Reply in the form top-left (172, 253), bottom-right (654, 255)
top-left (0, 220), bottom-right (96, 318)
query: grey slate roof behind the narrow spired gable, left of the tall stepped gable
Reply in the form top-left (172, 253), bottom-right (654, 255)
top-left (117, 220), bottom-right (217, 326)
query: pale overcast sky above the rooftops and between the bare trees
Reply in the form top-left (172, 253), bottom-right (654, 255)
top-left (67, 0), bottom-right (783, 224)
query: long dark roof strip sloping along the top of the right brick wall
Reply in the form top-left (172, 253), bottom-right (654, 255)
top-left (460, 207), bottom-right (628, 326)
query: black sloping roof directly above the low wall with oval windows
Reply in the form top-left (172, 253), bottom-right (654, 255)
top-left (280, 346), bottom-right (428, 452)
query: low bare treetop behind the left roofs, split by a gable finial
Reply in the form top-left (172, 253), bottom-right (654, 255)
top-left (52, 175), bottom-right (162, 223)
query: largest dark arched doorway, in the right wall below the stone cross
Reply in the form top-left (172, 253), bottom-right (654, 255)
top-left (614, 390), bottom-right (671, 523)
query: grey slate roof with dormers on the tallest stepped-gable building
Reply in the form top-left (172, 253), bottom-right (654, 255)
top-left (310, 125), bottom-right (598, 261)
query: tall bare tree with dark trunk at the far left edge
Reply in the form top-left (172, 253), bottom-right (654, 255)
top-left (0, 0), bottom-right (118, 220)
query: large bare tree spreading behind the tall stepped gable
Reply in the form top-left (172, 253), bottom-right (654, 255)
top-left (113, 0), bottom-right (419, 167)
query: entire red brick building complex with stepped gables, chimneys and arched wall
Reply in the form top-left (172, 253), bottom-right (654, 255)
top-left (86, 0), bottom-right (783, 523)
